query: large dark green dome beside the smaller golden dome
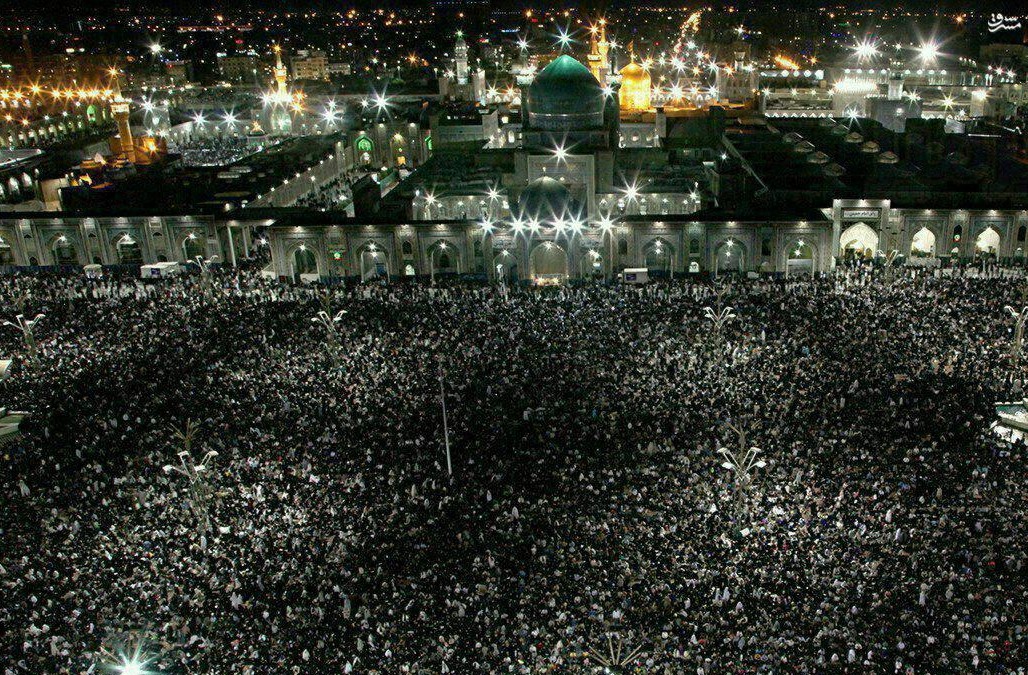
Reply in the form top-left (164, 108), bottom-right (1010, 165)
top-left (528, 54), bottom-right (604, 130)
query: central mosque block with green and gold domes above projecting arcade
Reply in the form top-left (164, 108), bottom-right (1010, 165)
top-left (257, 44), bottom-right (831, 282)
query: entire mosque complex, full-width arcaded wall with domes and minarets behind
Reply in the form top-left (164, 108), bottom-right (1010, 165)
top-left (0, 23), bottom-right (1028, 284)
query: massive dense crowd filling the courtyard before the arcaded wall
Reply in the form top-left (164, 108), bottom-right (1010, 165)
top-left (0, 268), bottom-right (1028, 675)
